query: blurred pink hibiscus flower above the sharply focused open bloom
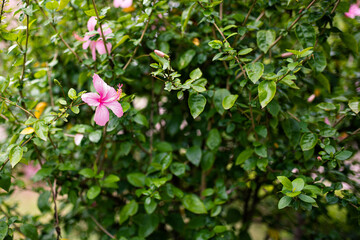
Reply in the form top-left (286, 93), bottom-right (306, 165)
top-left (74, 17), bottom-right (112, 61)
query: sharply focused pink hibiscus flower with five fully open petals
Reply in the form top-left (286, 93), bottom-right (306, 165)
top-left (81, 74), bottom-right (123, 126)
